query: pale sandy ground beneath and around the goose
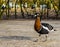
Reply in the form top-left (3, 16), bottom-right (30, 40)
top-left (0, 20), bottom-right (60, 47)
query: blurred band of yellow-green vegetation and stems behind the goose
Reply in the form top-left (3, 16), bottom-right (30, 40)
top-left (0, 0), bottom-right (60, 19)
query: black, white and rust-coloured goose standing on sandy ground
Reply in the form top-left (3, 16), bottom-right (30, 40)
top-left (34, 14), bottom-right (55, 41)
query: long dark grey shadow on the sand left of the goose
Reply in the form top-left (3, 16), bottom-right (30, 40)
top-left (0, 36), bottom-right (32, 40)
